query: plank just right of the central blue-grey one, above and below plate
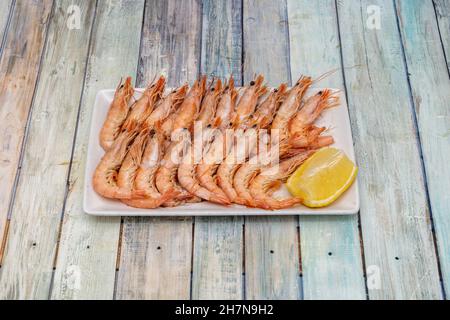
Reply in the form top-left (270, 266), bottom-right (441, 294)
top-left (243, 0), bottom-right (300, 299)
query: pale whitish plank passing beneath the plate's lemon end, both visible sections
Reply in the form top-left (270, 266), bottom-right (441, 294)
top-left (287, 0), bottom-right (366, 300)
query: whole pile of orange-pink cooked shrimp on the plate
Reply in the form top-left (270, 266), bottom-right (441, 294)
top-left (93, 75), bottom-right (339, 210)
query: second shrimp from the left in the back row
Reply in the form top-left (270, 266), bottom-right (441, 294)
top-left (122, 76), bottom-right (166, 131)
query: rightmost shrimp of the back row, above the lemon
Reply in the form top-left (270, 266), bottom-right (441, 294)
top-left (289, 89), bottom-right (339, 135)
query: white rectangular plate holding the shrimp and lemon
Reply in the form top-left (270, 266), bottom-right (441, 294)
top-left (83, 89), bottom-right (359, 216)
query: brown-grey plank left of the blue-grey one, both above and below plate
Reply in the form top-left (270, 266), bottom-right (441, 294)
top-left (117, 0), bottom-right (201, 299)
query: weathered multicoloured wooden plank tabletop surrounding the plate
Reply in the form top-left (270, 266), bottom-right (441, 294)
top-left (0, 0), bottom-right (450, 299)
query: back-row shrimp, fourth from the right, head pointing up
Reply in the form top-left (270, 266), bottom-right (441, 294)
top-left (233, 75), bottom-right (267, 129)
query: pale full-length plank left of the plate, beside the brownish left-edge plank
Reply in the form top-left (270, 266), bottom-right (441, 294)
top-left (0, 0), bottom-right (95, 299)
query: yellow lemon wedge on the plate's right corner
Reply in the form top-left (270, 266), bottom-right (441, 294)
top-left (286, 148), bottom-right (358, 208)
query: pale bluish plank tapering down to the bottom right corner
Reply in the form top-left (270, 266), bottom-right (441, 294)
top-left (396, 0), bottom-right (450, 292)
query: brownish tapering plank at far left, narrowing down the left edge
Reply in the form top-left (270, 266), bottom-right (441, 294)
top-left (0, 0), bottom-right (52, 262)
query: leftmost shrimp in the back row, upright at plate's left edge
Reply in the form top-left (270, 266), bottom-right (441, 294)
top-left (100, 77), bottom-right (134, 151)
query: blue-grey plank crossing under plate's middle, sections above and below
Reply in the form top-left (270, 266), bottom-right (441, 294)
top-left (192, 0), bottom-right (244, 300)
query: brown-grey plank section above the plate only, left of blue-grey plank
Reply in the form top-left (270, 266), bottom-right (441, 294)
top-left (138, 0), bottom-right (201, 87)
